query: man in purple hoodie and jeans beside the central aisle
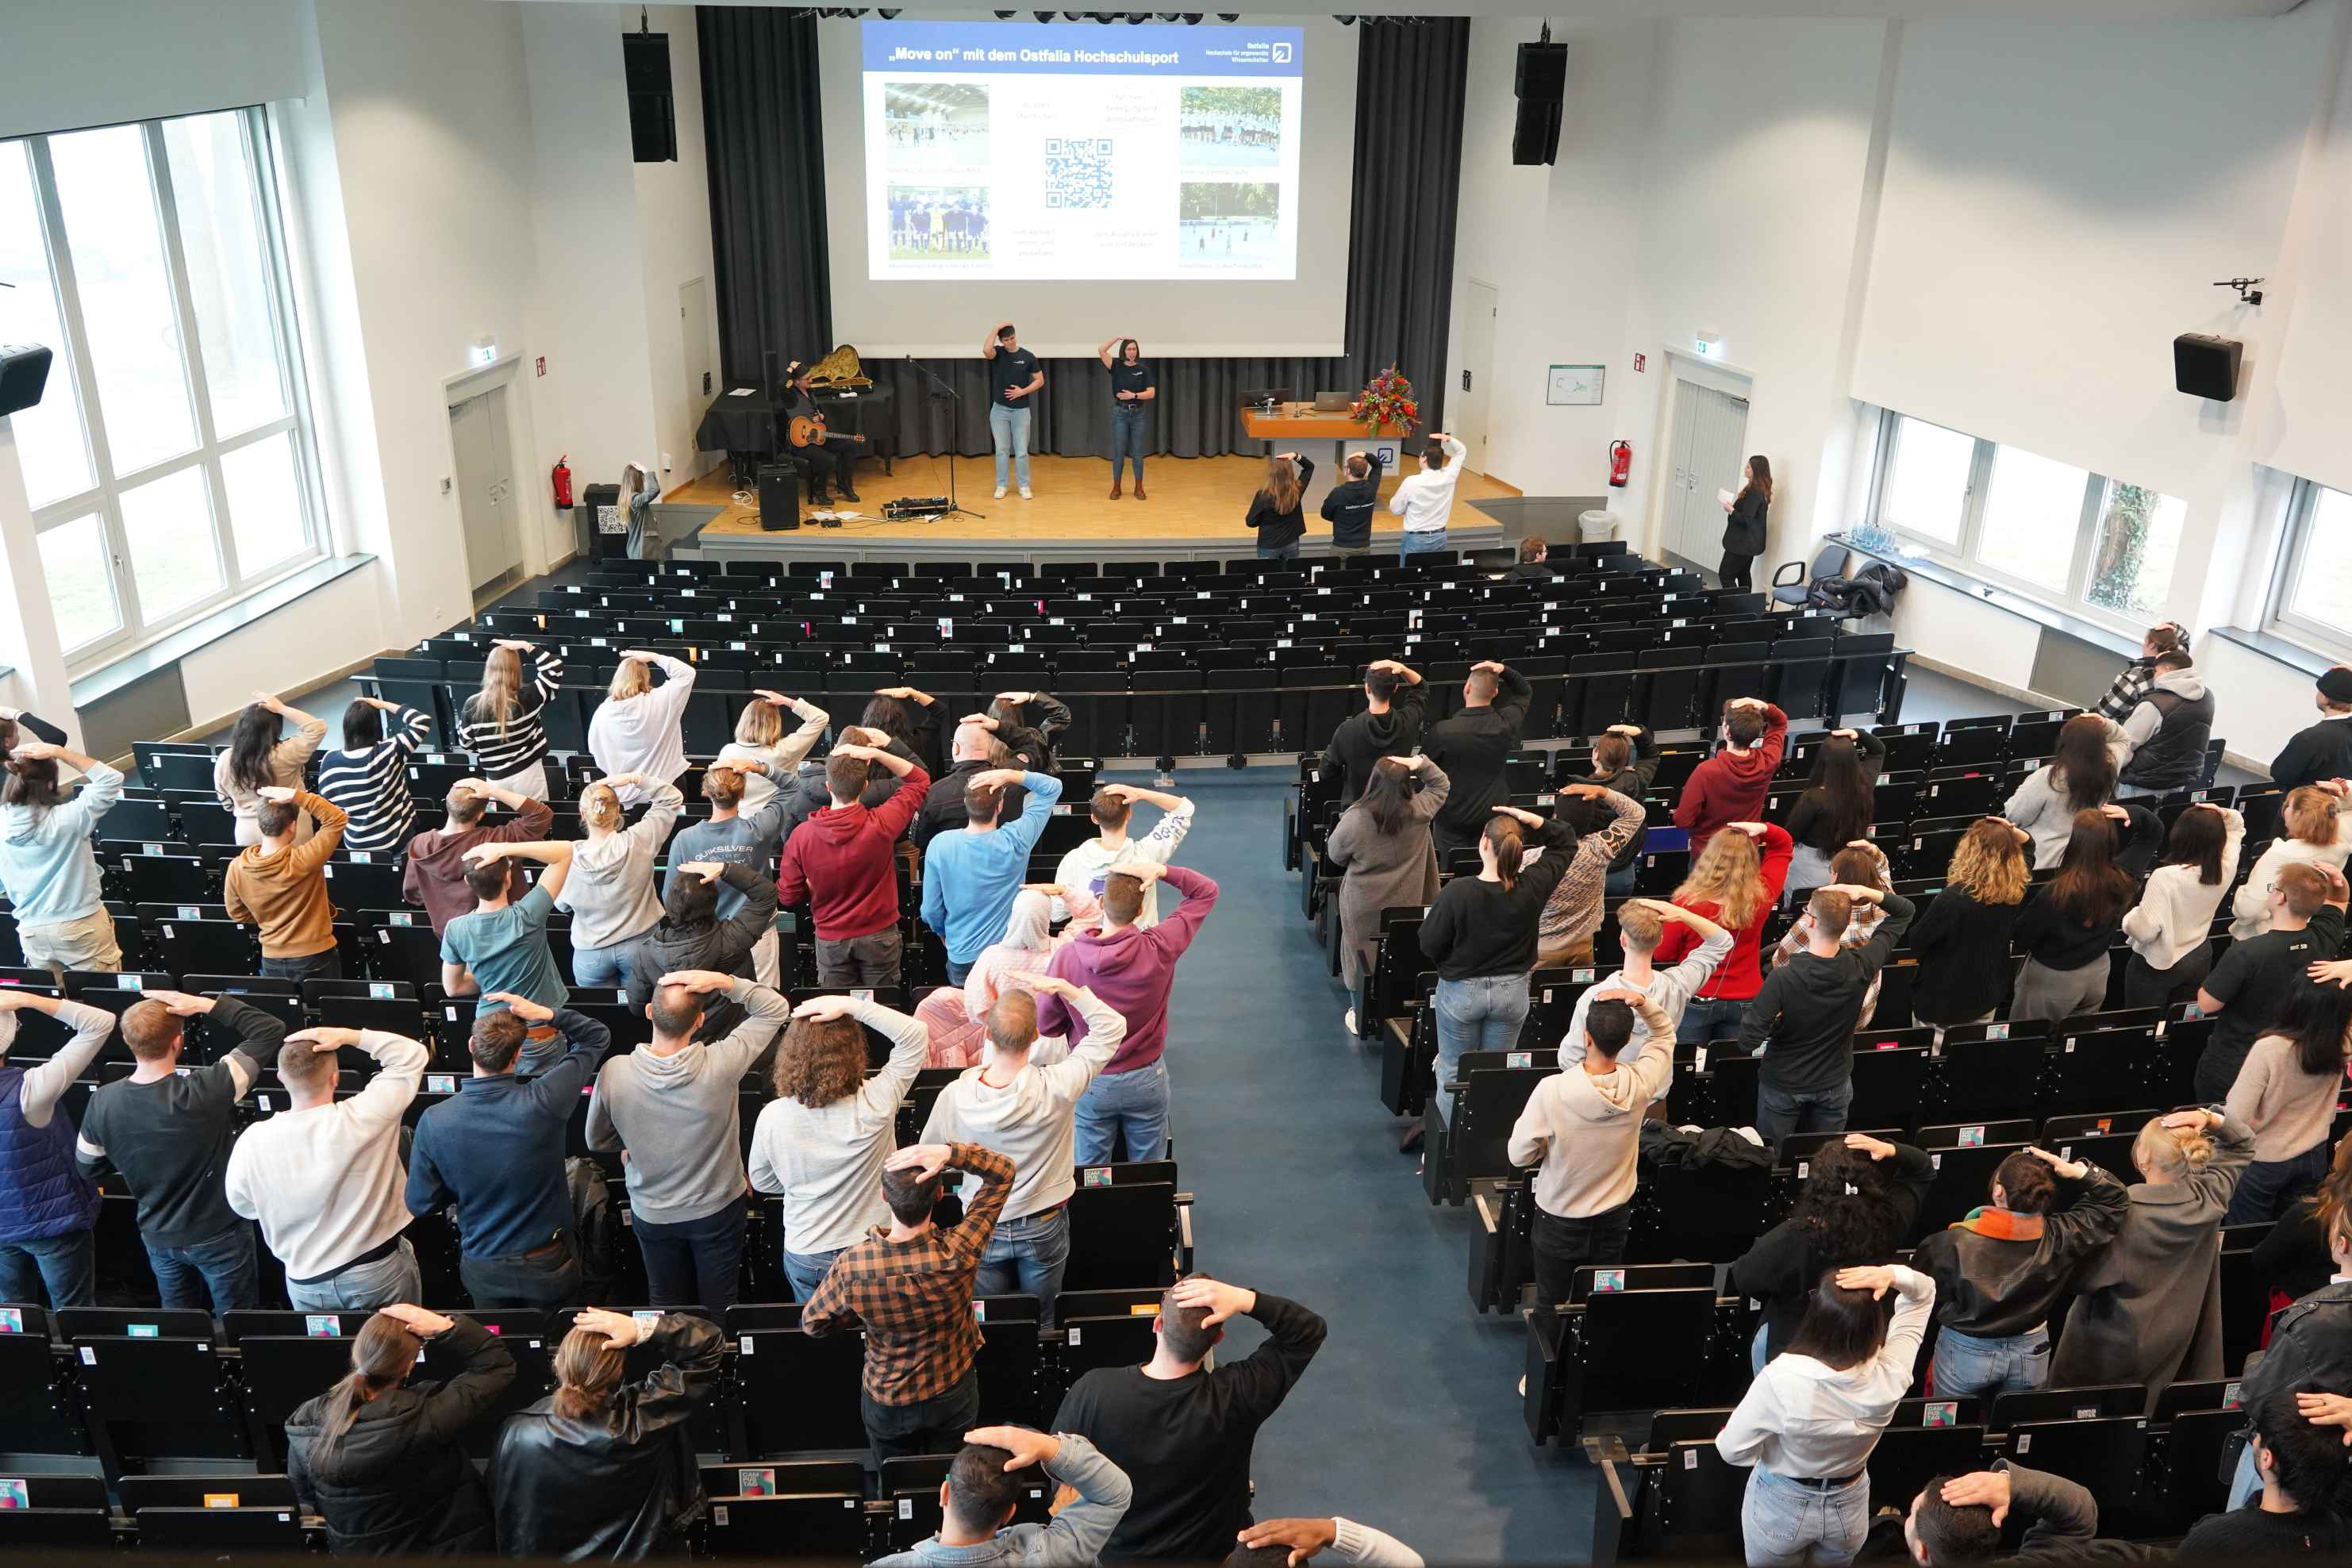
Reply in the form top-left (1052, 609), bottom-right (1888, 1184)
top-left (1037, 860), bottom-right (1216, 1166)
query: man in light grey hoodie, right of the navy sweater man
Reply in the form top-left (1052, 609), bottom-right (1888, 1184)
top-left (588, 969), bottom-right (793, 1312)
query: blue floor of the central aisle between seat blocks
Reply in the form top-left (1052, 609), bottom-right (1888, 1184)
top-left (1143, 769), bottom-right (1593, 1563)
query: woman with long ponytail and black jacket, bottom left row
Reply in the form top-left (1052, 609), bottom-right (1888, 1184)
top-left (285, 1302), bottom-right (515, 1556)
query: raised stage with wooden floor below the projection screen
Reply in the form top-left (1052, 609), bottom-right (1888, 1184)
top-left (663, 456), bottom-right (1520, 559)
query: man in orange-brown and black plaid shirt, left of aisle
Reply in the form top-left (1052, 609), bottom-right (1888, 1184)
top-left (800, 1143), bottom-right (1013, 1470)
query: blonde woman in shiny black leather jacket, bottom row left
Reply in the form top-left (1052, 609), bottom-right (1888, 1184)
top-left (490, 1307), bottom-right (727, 1561)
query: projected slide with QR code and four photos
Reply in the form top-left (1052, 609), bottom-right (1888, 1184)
top-left (859, 21), bottom-right (1305, 282)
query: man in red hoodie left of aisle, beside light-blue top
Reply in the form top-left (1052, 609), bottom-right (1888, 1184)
top-left (776, 743), bottom-right (932, 987)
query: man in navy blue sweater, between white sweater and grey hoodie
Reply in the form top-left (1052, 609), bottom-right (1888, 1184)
top-left (407, 992), bottom-right (612, 1309)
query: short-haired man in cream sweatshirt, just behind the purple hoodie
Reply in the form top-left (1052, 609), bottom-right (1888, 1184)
top-left (922, 971), bottom-right (1127, 1328)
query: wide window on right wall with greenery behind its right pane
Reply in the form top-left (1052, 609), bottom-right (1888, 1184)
top-left (1870, 411), bottom-right (2188, 630)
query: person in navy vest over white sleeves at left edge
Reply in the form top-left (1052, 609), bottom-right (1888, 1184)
top-left (0, 987), bottom-right (115, 1309)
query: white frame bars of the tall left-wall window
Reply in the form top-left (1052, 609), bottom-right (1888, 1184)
top-left (21, 106), bottom-right (327, 679)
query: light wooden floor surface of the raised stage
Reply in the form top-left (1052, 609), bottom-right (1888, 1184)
top-left (663, 456), bottom-right (1520, 550)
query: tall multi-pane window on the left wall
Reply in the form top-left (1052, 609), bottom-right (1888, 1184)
top-left (0, 108), bottom-right (325, 672)
